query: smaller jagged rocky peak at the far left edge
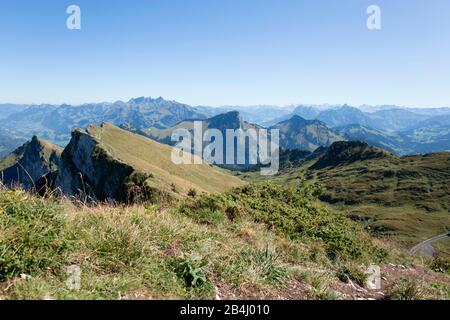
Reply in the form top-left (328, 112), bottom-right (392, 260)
top-left (0, 137), bottom-right (62, 189)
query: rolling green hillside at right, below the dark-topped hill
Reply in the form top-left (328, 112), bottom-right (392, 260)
top-left (241, 153), bottom-right (450, 246)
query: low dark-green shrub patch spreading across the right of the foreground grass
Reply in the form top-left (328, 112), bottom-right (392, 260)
top-left (181, 182), bottom-right (386, 262)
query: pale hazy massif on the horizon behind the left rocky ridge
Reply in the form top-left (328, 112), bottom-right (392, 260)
top-left (0, 97), bottom-right (206, 145)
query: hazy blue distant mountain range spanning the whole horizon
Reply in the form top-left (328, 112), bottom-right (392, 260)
top-left (0, 97), bottom-right (450, 158)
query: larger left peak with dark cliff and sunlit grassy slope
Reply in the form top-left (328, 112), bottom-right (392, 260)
top-left (57, 123), bottom-right (242, 201)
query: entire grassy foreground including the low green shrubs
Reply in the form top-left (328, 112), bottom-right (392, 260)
top-left (0, 183), bottom-right (450, 299)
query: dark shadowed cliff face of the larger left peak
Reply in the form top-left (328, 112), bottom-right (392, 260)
top-left (56, 129), bottom-right (134, 200)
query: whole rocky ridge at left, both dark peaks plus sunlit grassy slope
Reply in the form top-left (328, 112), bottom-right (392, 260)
top-left (0, 123), bottom-right (242, 203)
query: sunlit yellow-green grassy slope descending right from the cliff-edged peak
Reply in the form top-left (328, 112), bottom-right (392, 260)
top-left (89, 124), bottom-right (243, 193)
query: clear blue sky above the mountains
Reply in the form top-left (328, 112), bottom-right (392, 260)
top-left (0, 0), bottom-right (450, 106)
